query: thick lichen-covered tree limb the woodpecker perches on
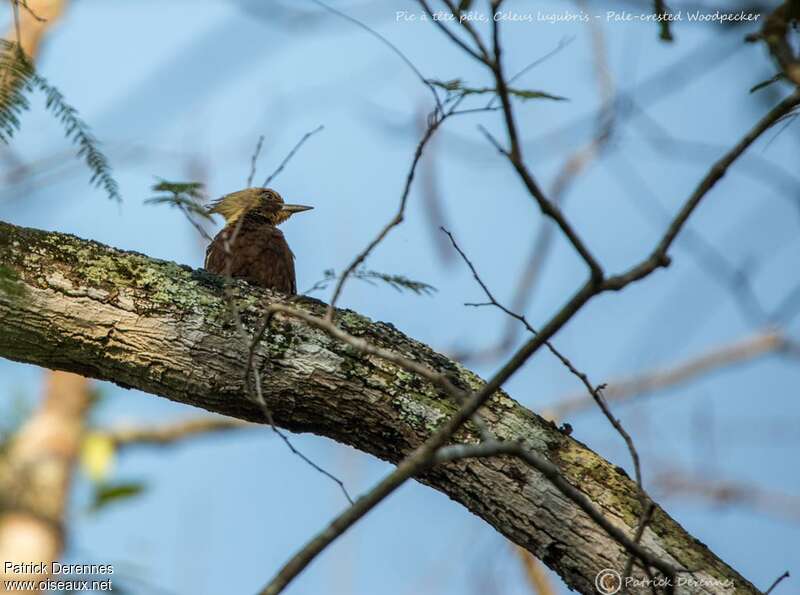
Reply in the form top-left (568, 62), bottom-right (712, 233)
top-left (0, 222), bottom-right (759, 593)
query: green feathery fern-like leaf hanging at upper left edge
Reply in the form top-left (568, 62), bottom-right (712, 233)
top-left (0, 40), bottom-right (122, 201)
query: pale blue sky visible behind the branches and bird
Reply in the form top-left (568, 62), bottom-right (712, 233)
top-left (0, 0), bottom-right (800, 595)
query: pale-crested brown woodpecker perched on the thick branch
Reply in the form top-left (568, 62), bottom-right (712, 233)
top-left (205, 188), bottom-right (314, 296)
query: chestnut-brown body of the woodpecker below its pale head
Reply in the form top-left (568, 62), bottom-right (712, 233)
top-left (205, 220), bottom-right (297, 295)
